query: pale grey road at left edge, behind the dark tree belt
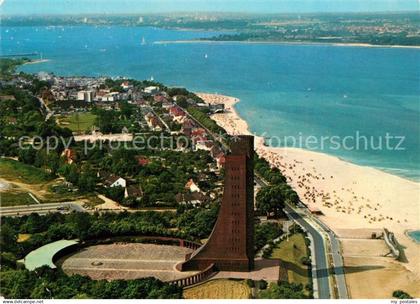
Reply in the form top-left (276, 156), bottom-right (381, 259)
top-left (0, 202), bottom-right (86, 216)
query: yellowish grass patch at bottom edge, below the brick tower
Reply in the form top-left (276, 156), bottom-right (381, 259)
top-left (184, 279), bottom-right (251, 299)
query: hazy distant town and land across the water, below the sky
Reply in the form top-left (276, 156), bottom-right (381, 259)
top-left (3, 12), bottom-right (419, 47)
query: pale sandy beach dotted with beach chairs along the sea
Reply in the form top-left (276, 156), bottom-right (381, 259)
top-left (197, 93), bottom-right (420, 298)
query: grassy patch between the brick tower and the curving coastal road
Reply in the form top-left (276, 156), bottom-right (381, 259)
top-left (271, 233), bottom-right (310, 286)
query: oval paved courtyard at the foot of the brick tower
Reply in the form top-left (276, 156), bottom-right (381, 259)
top-left (58, 243), bottom-right (196, 281)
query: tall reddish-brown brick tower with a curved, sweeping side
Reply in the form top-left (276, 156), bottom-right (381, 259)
top-left (177, 135), bottom-right (254, 271)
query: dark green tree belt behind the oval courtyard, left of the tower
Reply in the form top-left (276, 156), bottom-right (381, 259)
top-left (0, 204), bottom-right (218, 259)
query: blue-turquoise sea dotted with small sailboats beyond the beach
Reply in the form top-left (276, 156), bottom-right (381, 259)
top-left (1, 26), bottom-right (420, 181)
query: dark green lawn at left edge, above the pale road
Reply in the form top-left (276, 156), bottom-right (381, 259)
top-left (0, 159), bottom-right (51, 184)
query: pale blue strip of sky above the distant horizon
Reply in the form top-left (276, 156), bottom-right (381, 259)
top-left (0, 0), bottom-right (420, 15)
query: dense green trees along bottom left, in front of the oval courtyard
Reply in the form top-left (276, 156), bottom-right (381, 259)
top-left (0, 265), bottom-right (182, 299)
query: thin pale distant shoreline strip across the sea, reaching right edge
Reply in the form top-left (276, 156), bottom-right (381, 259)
top-left (153, 40), bottom-right (420, 49)
